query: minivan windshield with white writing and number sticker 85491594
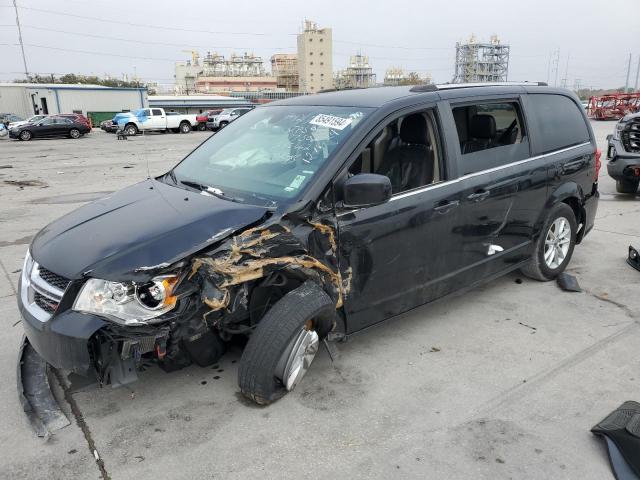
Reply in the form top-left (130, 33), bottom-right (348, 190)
top-left (173, 106), bottom-right (370, 205)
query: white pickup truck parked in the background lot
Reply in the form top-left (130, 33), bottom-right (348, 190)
top-left (111, 108), bottom-right (198, 135)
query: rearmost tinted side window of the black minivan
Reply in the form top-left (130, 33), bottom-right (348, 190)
top-left (527, 94), bottom-right (591, 154)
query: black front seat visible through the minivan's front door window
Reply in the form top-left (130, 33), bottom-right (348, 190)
top-left (376, 113), bottom-right (433, 193)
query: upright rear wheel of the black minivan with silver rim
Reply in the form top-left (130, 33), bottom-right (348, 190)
top-left (520, 203), bottom-right (578, 282)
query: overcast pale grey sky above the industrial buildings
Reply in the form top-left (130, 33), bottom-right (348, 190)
top-left (0, 0), bottom-right (640, 87)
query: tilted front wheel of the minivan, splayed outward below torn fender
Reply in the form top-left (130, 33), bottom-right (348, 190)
top-left (238, 281), bottom-right (335, 405)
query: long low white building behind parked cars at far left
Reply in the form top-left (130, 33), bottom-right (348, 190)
top-left (0, 83), bottom-right (149, 124)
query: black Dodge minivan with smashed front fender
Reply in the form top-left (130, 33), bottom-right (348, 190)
top-left (18, 83), bottom-right (600, 404)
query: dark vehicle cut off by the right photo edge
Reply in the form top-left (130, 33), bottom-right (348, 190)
top-left (607, 113), bottom-right (640, 194)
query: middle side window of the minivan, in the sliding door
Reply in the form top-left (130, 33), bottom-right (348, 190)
top-left (452, 101), bottom-right (530, 175)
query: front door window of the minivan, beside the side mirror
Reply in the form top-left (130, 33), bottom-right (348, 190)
top-left (348, 110), bottom-right (443, 195)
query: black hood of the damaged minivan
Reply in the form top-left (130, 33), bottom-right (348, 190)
top-left (31, 180), bottom-right (268, 281)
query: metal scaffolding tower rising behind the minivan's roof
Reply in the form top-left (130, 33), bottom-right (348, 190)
top-left (453, 35), bottom-right (509, 83)
